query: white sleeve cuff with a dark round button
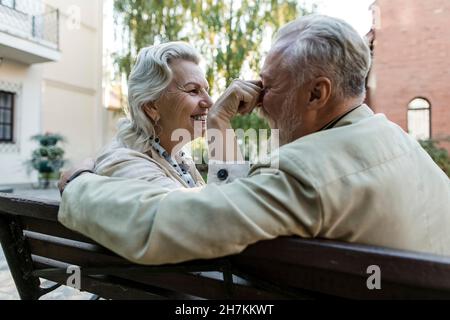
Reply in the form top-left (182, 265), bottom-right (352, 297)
top-left (208, 161), bottom-right (250, 184)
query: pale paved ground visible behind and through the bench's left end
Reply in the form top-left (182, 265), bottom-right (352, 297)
top-left (0, 185), bottom-right (92, 300)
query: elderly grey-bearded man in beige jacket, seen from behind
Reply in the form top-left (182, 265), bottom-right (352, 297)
top-left (59, 16), bottom-right (450, 264)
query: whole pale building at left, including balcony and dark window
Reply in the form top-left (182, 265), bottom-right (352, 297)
top-left (0, 0), bottom-right (108, 185)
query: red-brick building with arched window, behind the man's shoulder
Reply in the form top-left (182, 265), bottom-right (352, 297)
top-left (368, 0), bottom-right (450, 150)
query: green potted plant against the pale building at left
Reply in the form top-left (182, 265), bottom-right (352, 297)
top-left (30, 133), bottom-right (65, 189)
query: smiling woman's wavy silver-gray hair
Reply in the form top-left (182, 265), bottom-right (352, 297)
top-left (116, 41), bottom-right (200, 153)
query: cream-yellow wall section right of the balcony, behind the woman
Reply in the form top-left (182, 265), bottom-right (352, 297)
top-left (42, 0), bottom-right (106, 163)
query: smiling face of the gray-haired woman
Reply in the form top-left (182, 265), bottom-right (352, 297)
top-left (156, 59), bottom-right (213, 144)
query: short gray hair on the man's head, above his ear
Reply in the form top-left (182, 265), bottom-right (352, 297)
top-left (274, 15), bottom-right (371, 98)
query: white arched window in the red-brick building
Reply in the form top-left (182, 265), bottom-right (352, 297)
top-left (408, 98), bottom-right (431, 140)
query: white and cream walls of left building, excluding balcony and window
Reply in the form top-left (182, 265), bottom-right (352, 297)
top-left (0, 0), bottom-right (104, 185)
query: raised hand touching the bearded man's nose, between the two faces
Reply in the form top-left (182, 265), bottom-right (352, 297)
top-left (208, 80), bottom-right (262, 127)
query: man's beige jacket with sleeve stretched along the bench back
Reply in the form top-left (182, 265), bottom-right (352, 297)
top-left (59, 106), bottom-right (450, 264)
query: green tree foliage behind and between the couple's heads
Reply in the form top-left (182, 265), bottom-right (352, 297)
top-left (114, 0), bottom-right (314, 129)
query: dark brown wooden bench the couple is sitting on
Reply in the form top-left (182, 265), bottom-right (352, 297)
top-left (0, 194), bottom-right (450, 299)
